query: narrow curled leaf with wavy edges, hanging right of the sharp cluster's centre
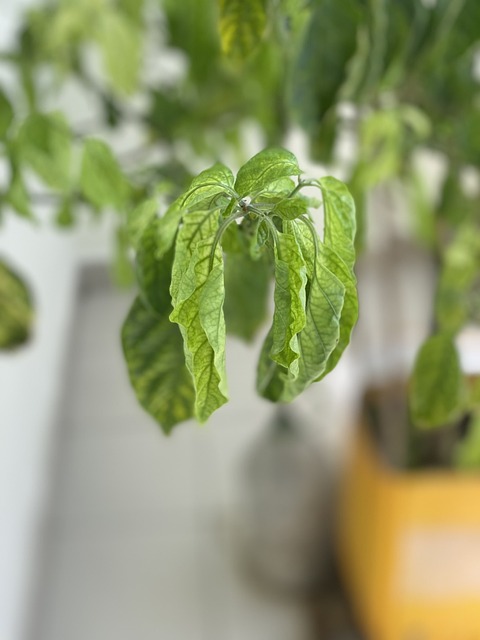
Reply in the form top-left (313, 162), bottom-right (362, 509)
top-left (270, 233), bottom-right (307, 377)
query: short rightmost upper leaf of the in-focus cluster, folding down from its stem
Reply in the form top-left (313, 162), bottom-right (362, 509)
top-left (318, 177), bottom-right (356, 270)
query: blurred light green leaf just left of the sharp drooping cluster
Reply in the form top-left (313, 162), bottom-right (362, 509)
top-left (80, 138), bottom-right (129, 209)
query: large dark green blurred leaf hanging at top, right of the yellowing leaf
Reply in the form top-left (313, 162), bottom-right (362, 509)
top-left (292, 0), bottom-right (362, 134)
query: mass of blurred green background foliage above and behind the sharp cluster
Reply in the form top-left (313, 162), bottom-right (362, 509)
top-left (0, 0), bottom-right (480, 448)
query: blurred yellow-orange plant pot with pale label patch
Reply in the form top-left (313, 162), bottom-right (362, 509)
top-left (337, 427), bottom-right (480, 640)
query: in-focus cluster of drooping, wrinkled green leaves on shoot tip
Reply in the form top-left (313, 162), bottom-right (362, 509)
top-left (122, 148), bottom-right (358, 431)
